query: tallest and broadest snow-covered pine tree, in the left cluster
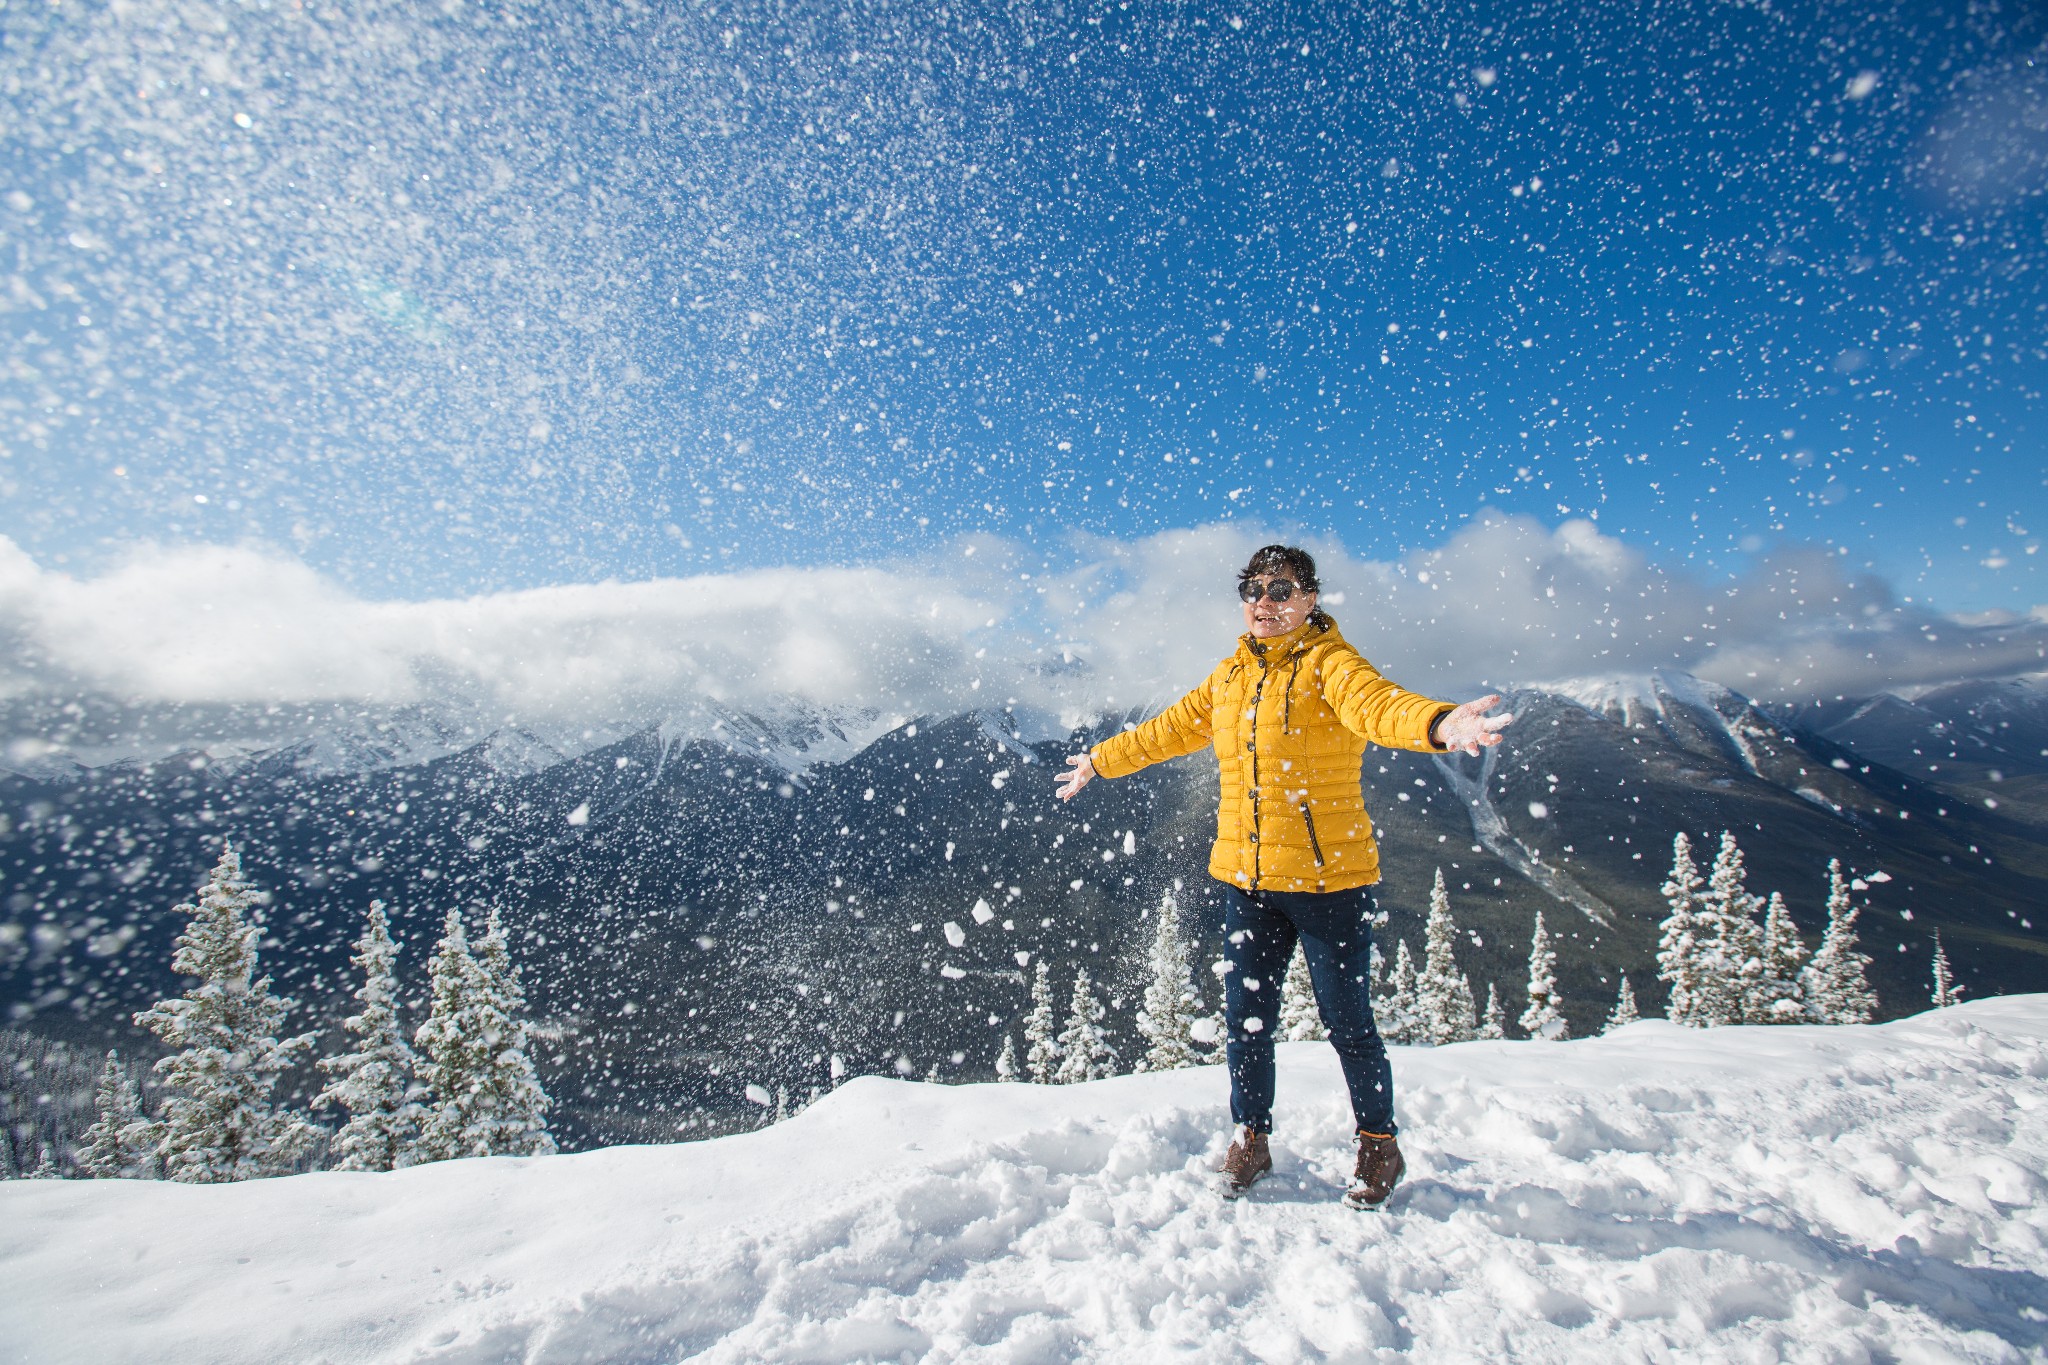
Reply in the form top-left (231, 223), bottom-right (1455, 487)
top-left (135, 845), bottom-right (313, 1183)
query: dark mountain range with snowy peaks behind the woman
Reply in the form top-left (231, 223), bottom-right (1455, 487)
top-left (0, 673), bottom-right (2048, 1146)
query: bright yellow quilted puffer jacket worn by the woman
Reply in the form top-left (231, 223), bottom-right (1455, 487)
top-left (1090, 616), bottom-right (1452, 892)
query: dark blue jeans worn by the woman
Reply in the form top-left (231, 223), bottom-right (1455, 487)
top-left (1223, 886), bottom-right (1395, 1134)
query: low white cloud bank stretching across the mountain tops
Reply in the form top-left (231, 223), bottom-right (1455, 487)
top-left (0, 516), bottom-right (2048, 722)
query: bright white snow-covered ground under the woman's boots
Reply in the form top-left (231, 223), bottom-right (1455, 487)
top-left (0, 997), bottom-right (2048, 1365)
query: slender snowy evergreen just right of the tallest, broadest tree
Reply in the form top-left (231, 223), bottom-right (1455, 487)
top-left (313, 900), bottom-right (422, 1171)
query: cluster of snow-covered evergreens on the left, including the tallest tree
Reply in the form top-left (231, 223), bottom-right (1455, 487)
top-left (68, 845), bottom-right (555, 1183)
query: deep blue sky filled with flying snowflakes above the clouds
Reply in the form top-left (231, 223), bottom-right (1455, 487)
top-left (0, 2), bottom-right (2048, 610)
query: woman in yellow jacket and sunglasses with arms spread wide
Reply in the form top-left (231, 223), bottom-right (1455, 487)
top-left (1059, 544), bottom-right (1513, 1207)
